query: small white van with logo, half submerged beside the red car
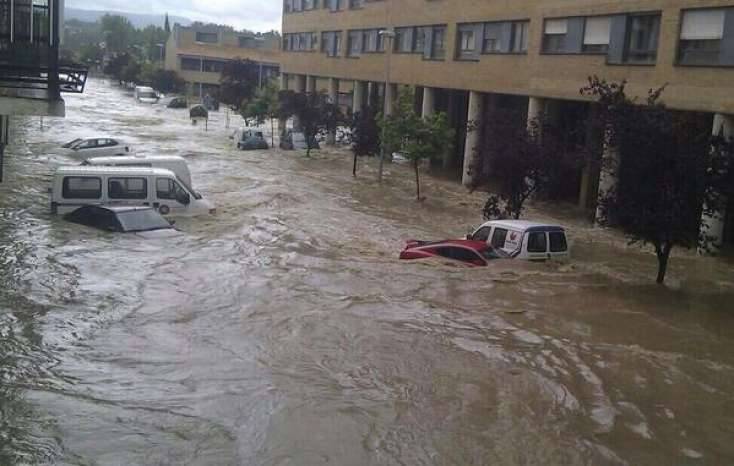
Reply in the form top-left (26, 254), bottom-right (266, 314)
top-left (466, 220), bottom-right (569, 261)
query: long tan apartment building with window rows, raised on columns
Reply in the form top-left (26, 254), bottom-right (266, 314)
top-left (281, 0), bottom-right (734, 246)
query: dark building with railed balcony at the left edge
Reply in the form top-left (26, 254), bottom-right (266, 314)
top-left (0, 0), bottom-right (87, 181)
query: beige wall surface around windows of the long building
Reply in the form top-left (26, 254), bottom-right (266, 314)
top-left (281, 0), bottom-right (734, 114)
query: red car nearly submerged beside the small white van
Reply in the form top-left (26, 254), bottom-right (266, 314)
top-left (400, 239), bottom-right (508, 267)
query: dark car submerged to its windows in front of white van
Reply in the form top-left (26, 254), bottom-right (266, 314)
top-left (64, 205), bottom-right (179, 236)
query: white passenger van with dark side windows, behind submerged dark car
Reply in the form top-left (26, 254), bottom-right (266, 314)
top-left (51, 166), bottom-right (215, 215)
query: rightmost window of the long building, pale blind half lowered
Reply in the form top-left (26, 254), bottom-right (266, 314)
top-left (678, 9), bottom-right (734, 65)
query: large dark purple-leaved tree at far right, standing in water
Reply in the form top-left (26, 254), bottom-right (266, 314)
top-left (581, 77), bottom-right (734, 284)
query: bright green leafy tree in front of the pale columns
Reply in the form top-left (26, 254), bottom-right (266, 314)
top-left (380, 90), bottom-right (454, 201)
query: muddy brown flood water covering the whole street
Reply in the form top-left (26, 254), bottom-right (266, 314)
top-left (0, 80), bottom-right (734, 466)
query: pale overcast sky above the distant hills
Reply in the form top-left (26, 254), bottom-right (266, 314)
top-left (66, 0), bottom-right (283, 32)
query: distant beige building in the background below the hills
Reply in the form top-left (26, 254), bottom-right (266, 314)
top-left (165, 24), bottom-right (281, 97)
